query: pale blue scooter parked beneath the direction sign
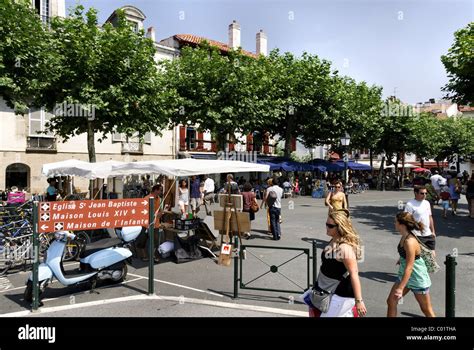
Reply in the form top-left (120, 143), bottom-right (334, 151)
top-left (23, 226), bottom-right (142, 302)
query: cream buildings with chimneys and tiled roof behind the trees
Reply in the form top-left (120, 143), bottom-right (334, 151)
top-left (0, 0), bottom-right (275, 193)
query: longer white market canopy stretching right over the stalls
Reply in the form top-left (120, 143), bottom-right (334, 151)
top-left (112, 158), bottom-right (270, 176)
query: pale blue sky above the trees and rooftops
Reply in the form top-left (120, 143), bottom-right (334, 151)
top-left (66, 0), bottom-right (474, 103)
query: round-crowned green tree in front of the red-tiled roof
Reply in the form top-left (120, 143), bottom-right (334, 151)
top-left (162, 43), bottom-right (278, 150)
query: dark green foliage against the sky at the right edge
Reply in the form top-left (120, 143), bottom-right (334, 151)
top-left (441, 22), bottom-right (474, 104)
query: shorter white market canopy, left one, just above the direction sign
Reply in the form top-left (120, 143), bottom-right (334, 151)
top-left (41, 159), bottom-right (123, 180)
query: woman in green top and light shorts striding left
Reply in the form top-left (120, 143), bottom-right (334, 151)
top-left (387, 212), bottom-right (435, 317)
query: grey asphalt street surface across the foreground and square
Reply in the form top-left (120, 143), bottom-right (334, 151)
top-left (0, 191), bottom-right (474, 317)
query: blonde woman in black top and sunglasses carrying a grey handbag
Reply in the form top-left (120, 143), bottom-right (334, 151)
top-left (315, 209), bottom-right (367, 317)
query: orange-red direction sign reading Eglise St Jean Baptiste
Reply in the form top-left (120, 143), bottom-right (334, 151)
top-left (38, 198), bottom-right (149, 233)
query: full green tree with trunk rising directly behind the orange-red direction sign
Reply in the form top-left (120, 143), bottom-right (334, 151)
top-left (36, 6), bottom-right (175, 162)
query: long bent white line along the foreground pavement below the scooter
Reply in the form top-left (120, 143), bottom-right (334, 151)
top-left (0, 294), bottom-right (308, 317)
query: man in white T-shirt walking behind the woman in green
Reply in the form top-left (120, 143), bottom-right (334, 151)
top-left (404, 186), bottom-right (436, 250)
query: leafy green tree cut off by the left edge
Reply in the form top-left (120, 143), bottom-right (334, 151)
top-left (0, 0), bottom-right (59, 114)
